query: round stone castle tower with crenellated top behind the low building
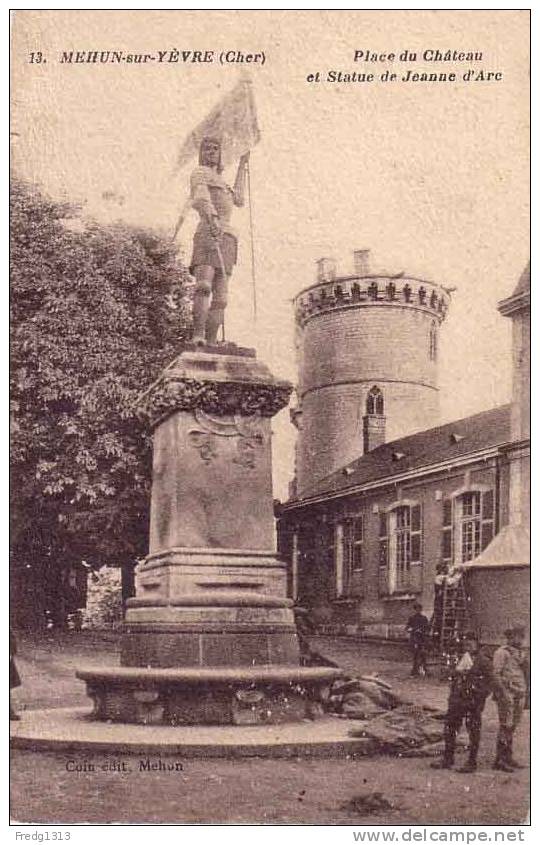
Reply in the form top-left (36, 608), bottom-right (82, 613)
top-left (291, 250), bottom-right (450, 495)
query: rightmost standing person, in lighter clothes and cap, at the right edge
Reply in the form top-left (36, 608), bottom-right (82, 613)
top-left (493, 625), bottom-right (528, 772)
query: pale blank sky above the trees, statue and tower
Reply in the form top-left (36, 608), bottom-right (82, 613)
top-left (12, 11), bottom-right (530, 499)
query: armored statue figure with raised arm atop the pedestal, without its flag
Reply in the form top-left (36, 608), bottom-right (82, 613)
top-left (190, 138), bottom-right (249, 346)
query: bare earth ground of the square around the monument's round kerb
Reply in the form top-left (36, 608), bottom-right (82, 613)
top-left (11, 634), bottom-right (529, 825)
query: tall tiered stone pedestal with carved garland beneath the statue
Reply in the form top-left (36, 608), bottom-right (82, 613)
top-left (79, 345), bottom-right (340, 724)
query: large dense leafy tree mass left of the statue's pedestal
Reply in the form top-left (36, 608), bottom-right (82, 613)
top-left (11, 180), bottom-right (192, 618)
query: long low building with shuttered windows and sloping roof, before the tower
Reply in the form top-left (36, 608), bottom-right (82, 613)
top-left (278, 405), bottom-right (511, 638)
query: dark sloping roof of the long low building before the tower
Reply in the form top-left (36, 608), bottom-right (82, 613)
top-left (286, 405), bottom-right (511, 506)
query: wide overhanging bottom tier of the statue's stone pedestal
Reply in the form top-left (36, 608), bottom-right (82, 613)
top-left (77, 666), bottom-right (343, 725)
